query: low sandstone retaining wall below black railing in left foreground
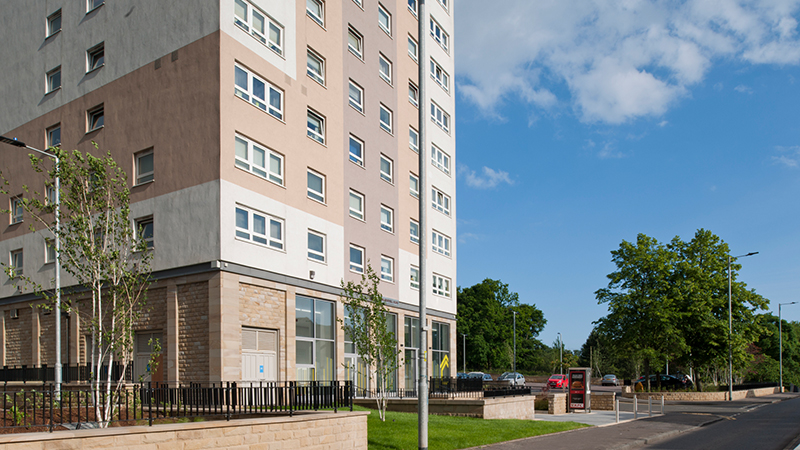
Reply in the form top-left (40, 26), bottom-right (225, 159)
top-left (0, 411), bottom-right (369, 450)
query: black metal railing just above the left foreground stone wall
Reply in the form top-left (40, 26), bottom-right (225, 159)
top-left (0, 381), bottom-right (354, 432)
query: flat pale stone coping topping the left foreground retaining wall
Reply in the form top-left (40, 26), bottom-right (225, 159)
top-left (0, 411), bottom-right (370, 445)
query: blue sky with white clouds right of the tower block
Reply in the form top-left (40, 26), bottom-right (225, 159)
top-left (455, 0), bottom-right (800, 349)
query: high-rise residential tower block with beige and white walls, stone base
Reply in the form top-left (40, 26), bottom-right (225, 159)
top-left (0, 0), bottom-right (456, 388)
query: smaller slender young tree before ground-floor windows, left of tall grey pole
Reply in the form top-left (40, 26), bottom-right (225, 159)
top-left (339, 264), bottom-right (400, 421)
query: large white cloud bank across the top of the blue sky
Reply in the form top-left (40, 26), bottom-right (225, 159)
top-left (456, 0), bottom-right (800, 124)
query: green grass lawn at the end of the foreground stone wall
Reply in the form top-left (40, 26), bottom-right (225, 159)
top-left (354, 408), bottom-right (588, 450)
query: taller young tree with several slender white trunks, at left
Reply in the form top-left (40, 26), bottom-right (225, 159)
top-left (1, 144), bottom-right (152, 426)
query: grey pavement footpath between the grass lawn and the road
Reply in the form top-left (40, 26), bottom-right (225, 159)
top-left (466, 393), bottom-right (798, 450)
